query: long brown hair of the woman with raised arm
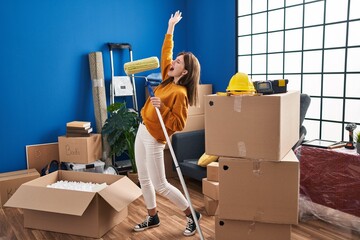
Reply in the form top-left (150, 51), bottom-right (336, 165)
top-left (161, 52), bottom-right (201, 106)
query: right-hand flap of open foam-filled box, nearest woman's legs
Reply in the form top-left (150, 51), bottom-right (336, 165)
top-left (98, 176), bottom-right (142, 212)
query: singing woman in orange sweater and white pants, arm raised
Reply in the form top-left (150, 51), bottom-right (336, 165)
top-left (134, 11), bottom-right (201, 236)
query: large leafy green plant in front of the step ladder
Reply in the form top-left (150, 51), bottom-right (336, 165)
top-left (101, 102), bottom-right (140, 182)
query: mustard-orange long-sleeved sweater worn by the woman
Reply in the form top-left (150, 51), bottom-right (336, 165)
top-left (141, 34), bottom-right (189, 143)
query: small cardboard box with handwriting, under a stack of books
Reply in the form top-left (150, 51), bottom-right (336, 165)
top-left (58, 134), bottom-right (102, 163)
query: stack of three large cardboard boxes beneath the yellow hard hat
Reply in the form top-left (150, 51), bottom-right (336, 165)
top-left (203, 91), bottom-right (300, 240)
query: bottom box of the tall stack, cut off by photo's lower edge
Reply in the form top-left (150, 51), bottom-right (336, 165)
top-left (215, 216), bottom-right (291, 240)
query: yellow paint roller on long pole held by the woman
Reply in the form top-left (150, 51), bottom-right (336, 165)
top-left (124, 57), bottom-right (204, 240)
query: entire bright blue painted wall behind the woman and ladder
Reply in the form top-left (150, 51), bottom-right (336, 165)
top-left (0, 0), bottom-right (236, 173)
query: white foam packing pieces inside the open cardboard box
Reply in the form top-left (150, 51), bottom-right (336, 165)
top-left (46, 180), bottom-right (107, 192)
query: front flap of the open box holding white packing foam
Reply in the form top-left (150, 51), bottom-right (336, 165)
top-left (4, 184), bottom-right (96, 216)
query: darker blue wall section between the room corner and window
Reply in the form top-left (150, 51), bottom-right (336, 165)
top-left (186, 0), bottom-right (236, 92)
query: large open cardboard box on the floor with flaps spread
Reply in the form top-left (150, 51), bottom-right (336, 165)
top-left (5, 171), bottom-right (141, 238)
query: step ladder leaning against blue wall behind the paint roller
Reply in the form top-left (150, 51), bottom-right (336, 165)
top-left (108, 43), bottom-right (138, 112)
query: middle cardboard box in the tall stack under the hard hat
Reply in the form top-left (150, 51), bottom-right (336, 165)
top-left (219, 150), bottom-right (300, 224)
